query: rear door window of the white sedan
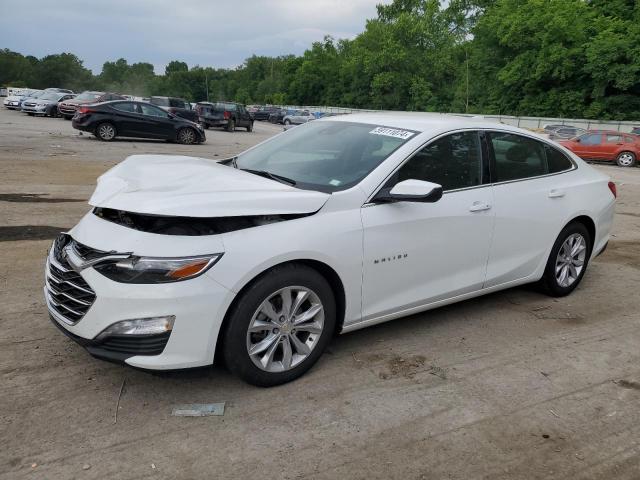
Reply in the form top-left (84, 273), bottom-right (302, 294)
top-left (491, 132), bottom-right (548, 182)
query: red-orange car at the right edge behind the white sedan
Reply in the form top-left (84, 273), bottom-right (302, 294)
top-left (558, 130), bottom-right (640, 167)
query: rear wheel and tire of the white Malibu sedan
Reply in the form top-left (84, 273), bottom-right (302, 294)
top-left (540, 222), bottom-right (592, 297)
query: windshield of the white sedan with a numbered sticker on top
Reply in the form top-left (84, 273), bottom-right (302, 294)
top-left (236, 121), bottom-right (417, 193)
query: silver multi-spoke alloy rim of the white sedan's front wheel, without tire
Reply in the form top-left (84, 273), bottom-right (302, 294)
top-left (247, 286), bottom-right (324, 373)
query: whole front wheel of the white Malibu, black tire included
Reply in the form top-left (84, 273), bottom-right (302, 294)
top-left (222, 264), bottom-right (336, 387)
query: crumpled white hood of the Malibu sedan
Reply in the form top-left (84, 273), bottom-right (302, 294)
top-left (89, 155), bottom-right (330, 217)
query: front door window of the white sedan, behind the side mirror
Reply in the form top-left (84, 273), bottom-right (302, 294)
top-left (395, 132), bottom-right (482, 191)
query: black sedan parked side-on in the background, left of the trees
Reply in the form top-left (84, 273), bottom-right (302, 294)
top-left (71, 100), bottom-right (206, 144)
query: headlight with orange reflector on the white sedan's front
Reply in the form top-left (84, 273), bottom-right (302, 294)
top-left (93, 253), bottom-right (222, 283)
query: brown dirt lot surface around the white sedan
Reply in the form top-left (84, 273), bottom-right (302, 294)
top-left (0, 109), bottom-right (640, 480)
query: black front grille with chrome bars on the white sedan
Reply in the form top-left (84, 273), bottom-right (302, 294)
top-left (47, 235), bottom-right (96, 323)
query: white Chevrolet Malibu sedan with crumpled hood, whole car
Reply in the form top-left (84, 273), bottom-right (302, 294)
top-left (44, 114), bottom-right (616, 386)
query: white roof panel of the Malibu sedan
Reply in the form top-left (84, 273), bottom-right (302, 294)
top-left (316, 112), bottom-right (539, 136)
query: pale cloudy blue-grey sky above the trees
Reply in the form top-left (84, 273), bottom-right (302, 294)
top-left (0, 0), bottom-right (390, 73)
